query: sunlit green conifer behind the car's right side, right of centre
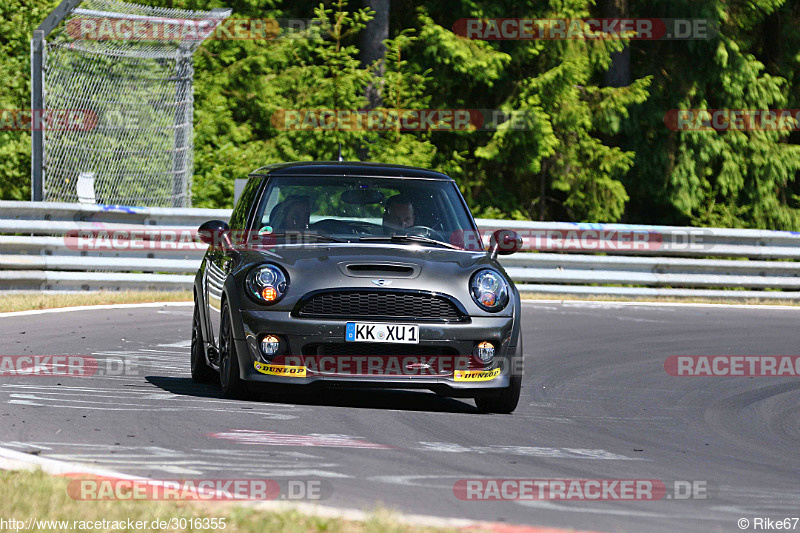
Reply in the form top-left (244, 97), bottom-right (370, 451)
top-left (406, 0), bottom-right (649, 222)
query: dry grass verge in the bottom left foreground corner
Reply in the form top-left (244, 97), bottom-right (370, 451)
top-left (0, 470), bottom-right (463, 533)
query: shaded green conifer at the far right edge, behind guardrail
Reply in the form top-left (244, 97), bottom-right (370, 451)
top-left (621, 0), bottom-right (800, 229)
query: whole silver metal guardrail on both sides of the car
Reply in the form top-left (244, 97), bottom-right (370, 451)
top-left (0, 201), bottom-right (800, 299)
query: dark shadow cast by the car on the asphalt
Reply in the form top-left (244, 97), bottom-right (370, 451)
top-left (145, 376), bottom-right (478, 414)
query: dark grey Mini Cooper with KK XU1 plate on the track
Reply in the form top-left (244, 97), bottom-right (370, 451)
top-left (191, 162), bottom-right (523, 413)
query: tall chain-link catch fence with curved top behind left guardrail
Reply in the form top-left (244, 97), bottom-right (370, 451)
top-left (43, 0), bottom-right (230, 207)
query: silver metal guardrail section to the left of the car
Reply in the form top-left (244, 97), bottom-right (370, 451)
top-left (0, 201), bottom-right (219, 290)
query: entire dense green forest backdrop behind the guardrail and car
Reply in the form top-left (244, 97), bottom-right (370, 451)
top-left (6, 0), bottom-right (800, 229)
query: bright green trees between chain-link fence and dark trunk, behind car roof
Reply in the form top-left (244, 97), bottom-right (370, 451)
top-left (188, 0), bottom-right (435, 206)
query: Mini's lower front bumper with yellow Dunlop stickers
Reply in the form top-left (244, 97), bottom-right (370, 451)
top-left (236, 310), bottom-right (521, 396)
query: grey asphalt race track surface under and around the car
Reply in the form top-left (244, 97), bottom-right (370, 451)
top-left (0, 302), bottom-right (800, 532)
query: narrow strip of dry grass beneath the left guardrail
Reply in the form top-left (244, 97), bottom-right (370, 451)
top-left (0, 291), bottom-right (192, 313)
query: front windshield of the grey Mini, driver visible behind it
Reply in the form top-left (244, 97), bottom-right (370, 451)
top-left (252, 176), bottom-right (482, 249)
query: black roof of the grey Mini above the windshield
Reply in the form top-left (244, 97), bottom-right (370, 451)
top-left (250, 161), bottom-right (453, 181)
